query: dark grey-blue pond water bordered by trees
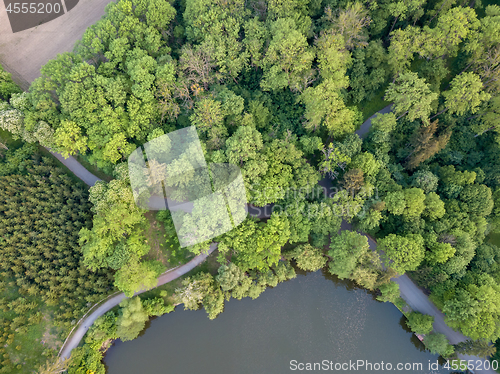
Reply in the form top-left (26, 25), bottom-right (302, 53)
top-left (104, 271), bottom-right (449, 374)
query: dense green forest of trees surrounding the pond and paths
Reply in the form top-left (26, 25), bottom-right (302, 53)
top-left (0, 0), bottom-right (500, 374)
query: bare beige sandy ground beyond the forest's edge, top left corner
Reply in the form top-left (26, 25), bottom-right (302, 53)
top-left (0, 0), bottom-right (115, 90)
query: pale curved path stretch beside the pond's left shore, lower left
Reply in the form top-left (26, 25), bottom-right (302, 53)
top-left (60, 243), bottom-right (217, 358)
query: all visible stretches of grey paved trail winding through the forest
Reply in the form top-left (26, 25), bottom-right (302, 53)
top-left (49, 105), bottom-right (496, 374)
